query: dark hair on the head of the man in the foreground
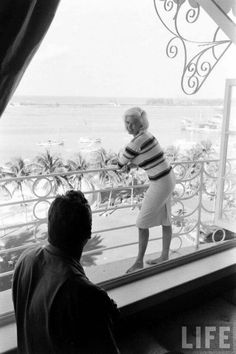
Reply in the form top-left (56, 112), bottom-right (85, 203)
top-left (48, 190), bottom-right (92, 255)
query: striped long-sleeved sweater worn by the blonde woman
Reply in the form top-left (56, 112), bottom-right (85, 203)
top-left (118, 131), bottom-right (171, 181)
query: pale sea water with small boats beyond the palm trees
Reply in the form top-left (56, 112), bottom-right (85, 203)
top-left (0, 97), bottom-right (220, 165)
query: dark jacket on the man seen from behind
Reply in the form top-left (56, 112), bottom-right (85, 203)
top-left (13, 245), bottom-right (119, 354)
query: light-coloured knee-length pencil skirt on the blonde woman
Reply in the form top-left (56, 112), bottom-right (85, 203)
top-left (136, 170), bottom-right (175, 229)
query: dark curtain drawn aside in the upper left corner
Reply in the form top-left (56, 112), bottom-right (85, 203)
top-left (0, 0), bottom-right (60, 116)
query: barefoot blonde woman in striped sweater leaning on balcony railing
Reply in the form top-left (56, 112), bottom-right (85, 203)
top-left (118, 107), bottom-right (175, 273)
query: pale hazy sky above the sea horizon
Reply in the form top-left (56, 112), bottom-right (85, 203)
top-left (16, 0), bottom-right (236, 98)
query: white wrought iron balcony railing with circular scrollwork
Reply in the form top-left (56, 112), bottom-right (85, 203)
top-left (0, 160), bottom-right (235, 291)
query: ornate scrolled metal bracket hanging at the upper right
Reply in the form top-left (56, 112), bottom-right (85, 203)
top-left (154, 0), bottom-right (232, 95)
